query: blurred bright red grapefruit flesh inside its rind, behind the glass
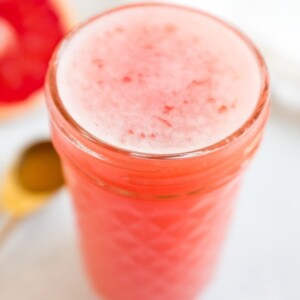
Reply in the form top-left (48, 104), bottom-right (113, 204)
top-left (0, 0), bottom-right (66, 105)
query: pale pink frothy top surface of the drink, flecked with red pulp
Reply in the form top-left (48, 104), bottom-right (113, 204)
top-left (57, 5), bottom-right (261, 154)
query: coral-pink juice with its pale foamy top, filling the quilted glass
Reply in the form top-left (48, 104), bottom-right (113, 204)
top-left (48, 4), bottom-right (268, 300)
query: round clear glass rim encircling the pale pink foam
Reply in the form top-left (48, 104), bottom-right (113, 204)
top-left (46, 3), bottom-right (269, 160)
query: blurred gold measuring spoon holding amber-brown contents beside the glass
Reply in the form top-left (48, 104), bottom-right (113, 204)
top-left (0, 141), bottom-right (64, 245)
